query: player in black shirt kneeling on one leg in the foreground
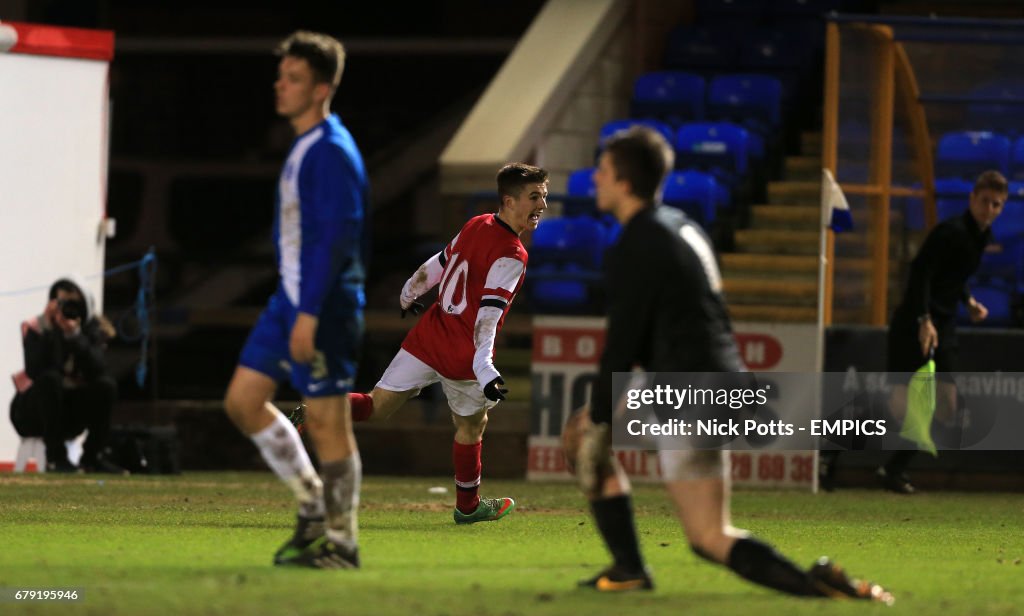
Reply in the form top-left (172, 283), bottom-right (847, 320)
top-left (563, 127), bottom-right (892, 603)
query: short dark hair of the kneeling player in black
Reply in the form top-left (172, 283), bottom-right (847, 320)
top-left (604, 126), bottom-right (676, 202)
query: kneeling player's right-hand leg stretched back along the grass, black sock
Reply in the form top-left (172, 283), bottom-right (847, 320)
top-left (659, 450), bottom-right (892, 603)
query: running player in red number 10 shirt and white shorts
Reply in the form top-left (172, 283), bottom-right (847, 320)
top-left (349, 163), bottom-right (548, 524)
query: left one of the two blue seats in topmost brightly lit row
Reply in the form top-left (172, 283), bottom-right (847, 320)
top-left (630, 71), bottom-right (706, 126)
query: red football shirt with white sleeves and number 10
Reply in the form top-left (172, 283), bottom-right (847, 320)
top-left (401, 214), bottom-right (527, 381)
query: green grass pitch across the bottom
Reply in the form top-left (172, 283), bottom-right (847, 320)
top-left (0, 473), bottom-right (1024, 616)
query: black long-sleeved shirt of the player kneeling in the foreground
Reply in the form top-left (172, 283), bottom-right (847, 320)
top-left (591, 206), bottom-right (743, 424)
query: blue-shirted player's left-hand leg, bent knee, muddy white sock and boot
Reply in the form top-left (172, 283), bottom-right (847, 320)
top-left (224, 366), bottom-right (324, 565)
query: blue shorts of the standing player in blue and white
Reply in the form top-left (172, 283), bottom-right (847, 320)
top-left (239, 284), bottom-right (367, 398)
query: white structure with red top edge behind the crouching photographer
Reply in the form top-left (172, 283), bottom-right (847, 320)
top-left (0, 21), bottom-right (114, 470)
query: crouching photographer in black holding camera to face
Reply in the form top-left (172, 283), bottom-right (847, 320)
top-left (10, 278), bottom-right (124, 474)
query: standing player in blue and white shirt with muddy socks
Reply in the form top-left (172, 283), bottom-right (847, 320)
top-left (224, 32), bottom-right (369, 569)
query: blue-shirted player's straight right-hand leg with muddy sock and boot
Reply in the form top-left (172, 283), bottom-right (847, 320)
top-left (298, 395), bottom-right (362, 569)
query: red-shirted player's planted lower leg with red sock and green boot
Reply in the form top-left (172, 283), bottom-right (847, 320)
top-left (452, 408), bottom-right (515, 524)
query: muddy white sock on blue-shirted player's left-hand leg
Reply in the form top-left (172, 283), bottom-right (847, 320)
top-left (250, 409), bottom-right (324, 518)
